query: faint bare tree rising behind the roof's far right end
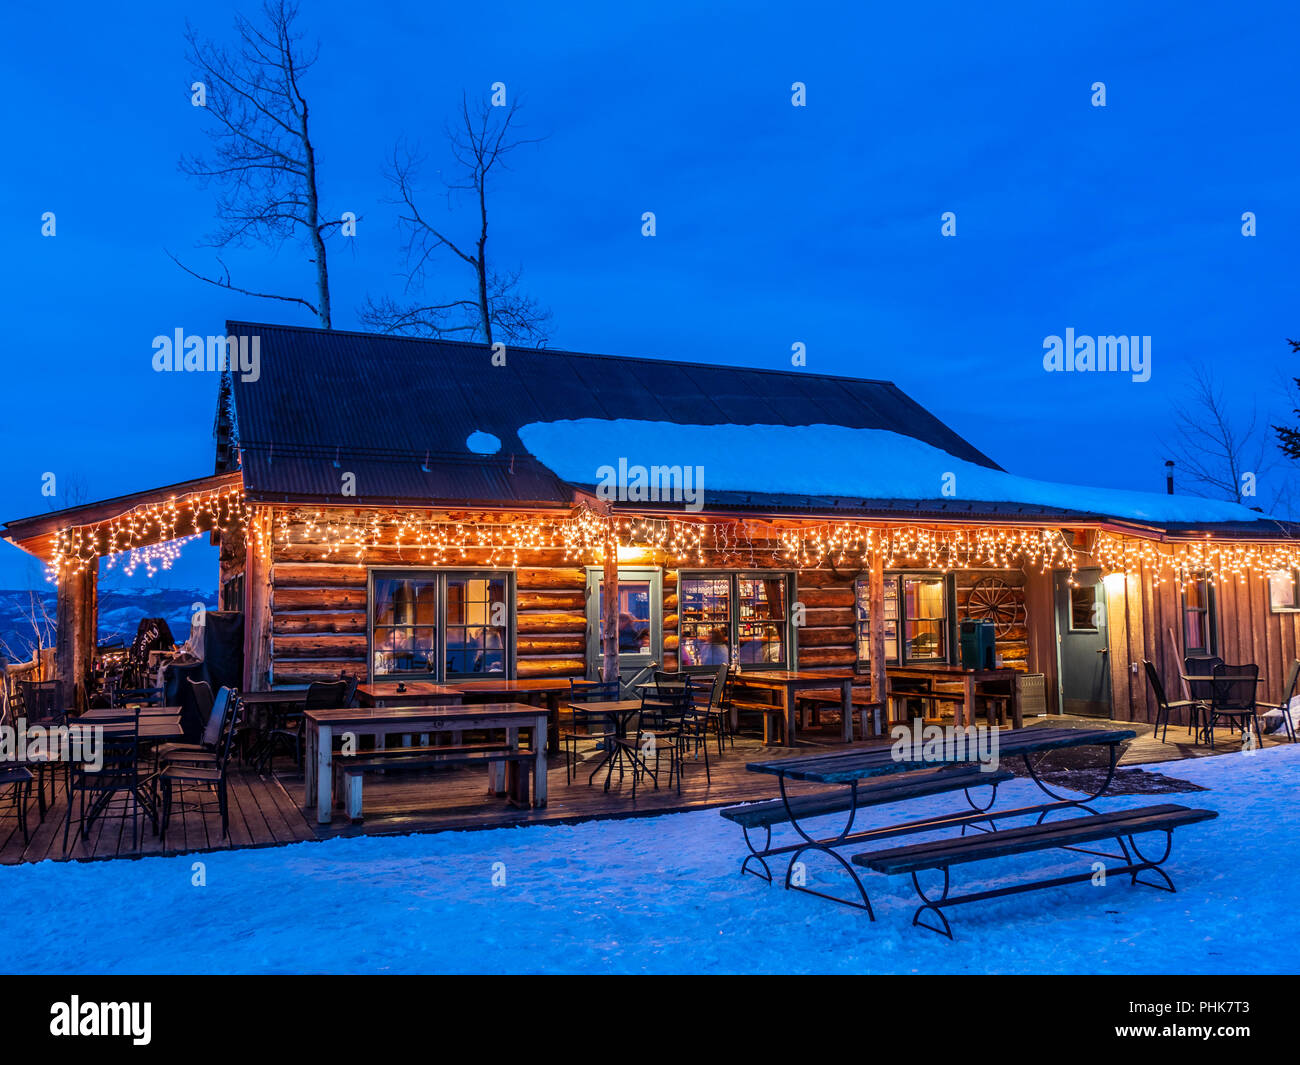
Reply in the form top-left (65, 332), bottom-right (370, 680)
top-left (1166, 367), bottom-right (1284, 507)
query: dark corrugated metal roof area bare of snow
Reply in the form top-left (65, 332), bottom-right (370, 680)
top-left (228, 321), bottom-right (1000, 505)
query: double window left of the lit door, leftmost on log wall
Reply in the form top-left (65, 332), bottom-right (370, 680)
top-left (371, 570), bottom-right (514, 680)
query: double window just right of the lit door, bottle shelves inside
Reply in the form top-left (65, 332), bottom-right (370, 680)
top-left (677, 573), bottom-right (789, 668)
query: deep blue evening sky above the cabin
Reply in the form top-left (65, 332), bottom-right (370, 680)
top-left (0, 3), bottom-right (1300, 588)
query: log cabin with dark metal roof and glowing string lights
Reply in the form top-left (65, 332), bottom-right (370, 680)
top-left (4, 321), bottom-right (1300, 722)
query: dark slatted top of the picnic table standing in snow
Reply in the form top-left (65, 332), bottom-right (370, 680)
top-left (745, 726), bottom-right (1138, 784)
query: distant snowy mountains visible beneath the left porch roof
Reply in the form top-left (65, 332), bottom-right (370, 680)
top-left (0, 586), bottom-right (202, 661)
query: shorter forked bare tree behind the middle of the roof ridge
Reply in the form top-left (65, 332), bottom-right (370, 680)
top-left (359, 95), bottom-right (551, 347)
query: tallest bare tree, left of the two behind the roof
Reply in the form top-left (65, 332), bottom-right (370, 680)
top-left (168, 0), bottom-right (343, 329)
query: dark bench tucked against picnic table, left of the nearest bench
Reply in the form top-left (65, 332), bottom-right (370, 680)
top-left (719, 766), bottom-right (1014, 889)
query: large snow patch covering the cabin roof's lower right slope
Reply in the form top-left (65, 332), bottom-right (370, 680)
top-left (519, 417), bottom-right (1265, 524)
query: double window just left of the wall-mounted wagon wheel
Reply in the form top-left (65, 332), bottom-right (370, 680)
top-left (854, 573), bottom-right (953, 666)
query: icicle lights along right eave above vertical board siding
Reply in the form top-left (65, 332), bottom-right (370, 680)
top-left (1092, 533), bottom-right (1300, 583)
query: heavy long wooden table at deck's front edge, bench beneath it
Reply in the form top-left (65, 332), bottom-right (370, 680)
top-left (303, 702), bottom-right (547, 824)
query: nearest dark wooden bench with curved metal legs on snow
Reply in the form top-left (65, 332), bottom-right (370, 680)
top-left (853, 804), bottom-right (1218, 939)
